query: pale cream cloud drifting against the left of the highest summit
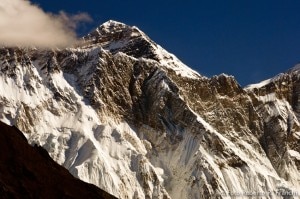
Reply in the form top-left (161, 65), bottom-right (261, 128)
top-left (0, 0), bottom-right (92, 47)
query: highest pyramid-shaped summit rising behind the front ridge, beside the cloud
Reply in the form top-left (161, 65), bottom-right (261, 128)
top-left (83, 20), bottom-right (200, 78)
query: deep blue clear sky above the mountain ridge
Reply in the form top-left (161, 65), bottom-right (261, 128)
top-left (31, 0), bottom-right (300, 86)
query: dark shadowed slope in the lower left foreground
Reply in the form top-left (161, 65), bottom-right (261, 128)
top-left (0, 122), bottom-right (115, 199)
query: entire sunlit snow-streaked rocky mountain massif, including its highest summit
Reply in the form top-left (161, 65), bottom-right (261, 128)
top-left (0, 21), bottom-right (300, 199)
